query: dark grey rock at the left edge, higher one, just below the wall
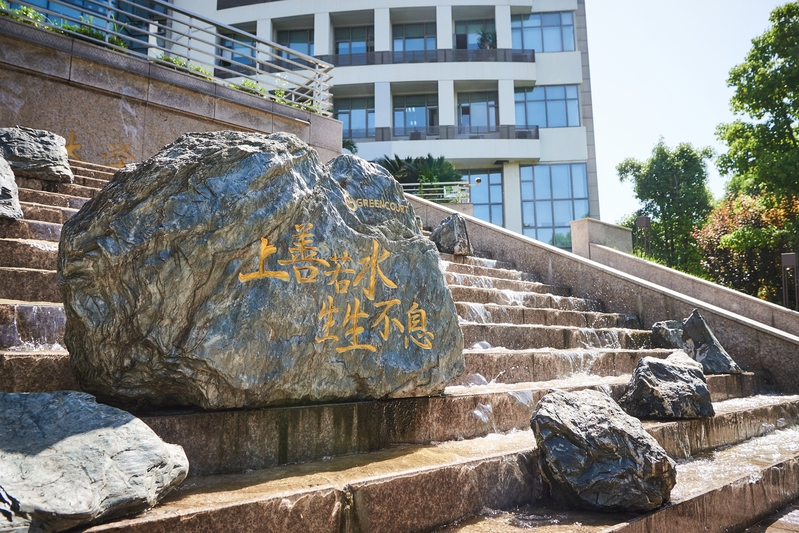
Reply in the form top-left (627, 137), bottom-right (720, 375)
top-left (0, 126), bottom-right (75, 183)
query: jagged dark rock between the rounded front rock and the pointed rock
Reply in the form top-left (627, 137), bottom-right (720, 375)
top-left (619, 352), bottom-right (715, 418)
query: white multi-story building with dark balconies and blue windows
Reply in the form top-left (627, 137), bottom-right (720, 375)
top-left (174, 0), bottom-right (599, 247)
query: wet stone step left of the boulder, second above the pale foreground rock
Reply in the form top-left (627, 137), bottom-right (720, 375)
top-left (0, 300), bottom-right (66, 351)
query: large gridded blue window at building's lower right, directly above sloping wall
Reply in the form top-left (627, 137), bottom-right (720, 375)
top-left (519, 163), bottom-right (589, 249)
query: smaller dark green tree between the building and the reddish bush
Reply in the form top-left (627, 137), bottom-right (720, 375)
top-left (616, 138), bottom-right (713, 275)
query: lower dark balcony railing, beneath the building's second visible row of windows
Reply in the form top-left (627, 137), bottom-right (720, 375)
top-left (344, 125), bottom-right (539, 142)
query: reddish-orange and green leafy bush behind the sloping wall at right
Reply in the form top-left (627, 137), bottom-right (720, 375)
top-left (694, 193), bottom-right (799, 303)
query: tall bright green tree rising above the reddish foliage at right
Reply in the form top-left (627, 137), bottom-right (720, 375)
top-left (716, 1), bottom-right (799, 194)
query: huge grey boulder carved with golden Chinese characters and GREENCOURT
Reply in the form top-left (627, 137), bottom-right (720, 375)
top-left (58, 132), bottom-right (464, 409)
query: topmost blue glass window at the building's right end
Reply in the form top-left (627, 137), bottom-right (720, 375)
top-left (511, 11), bottom-right (575, 52)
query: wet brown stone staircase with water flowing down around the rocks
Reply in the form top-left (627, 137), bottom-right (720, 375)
top-left (0, 162), bottom-right (799, 533)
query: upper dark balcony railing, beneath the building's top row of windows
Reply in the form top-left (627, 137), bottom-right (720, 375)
top-left (318, 49), bottom-right (535, 67)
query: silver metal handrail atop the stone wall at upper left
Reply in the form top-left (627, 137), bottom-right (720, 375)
top-left (0, 0), bottom-right (333, 116)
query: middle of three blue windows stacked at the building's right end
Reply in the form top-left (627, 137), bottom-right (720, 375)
top-left (514, 85), bottom-right (580, 129)
